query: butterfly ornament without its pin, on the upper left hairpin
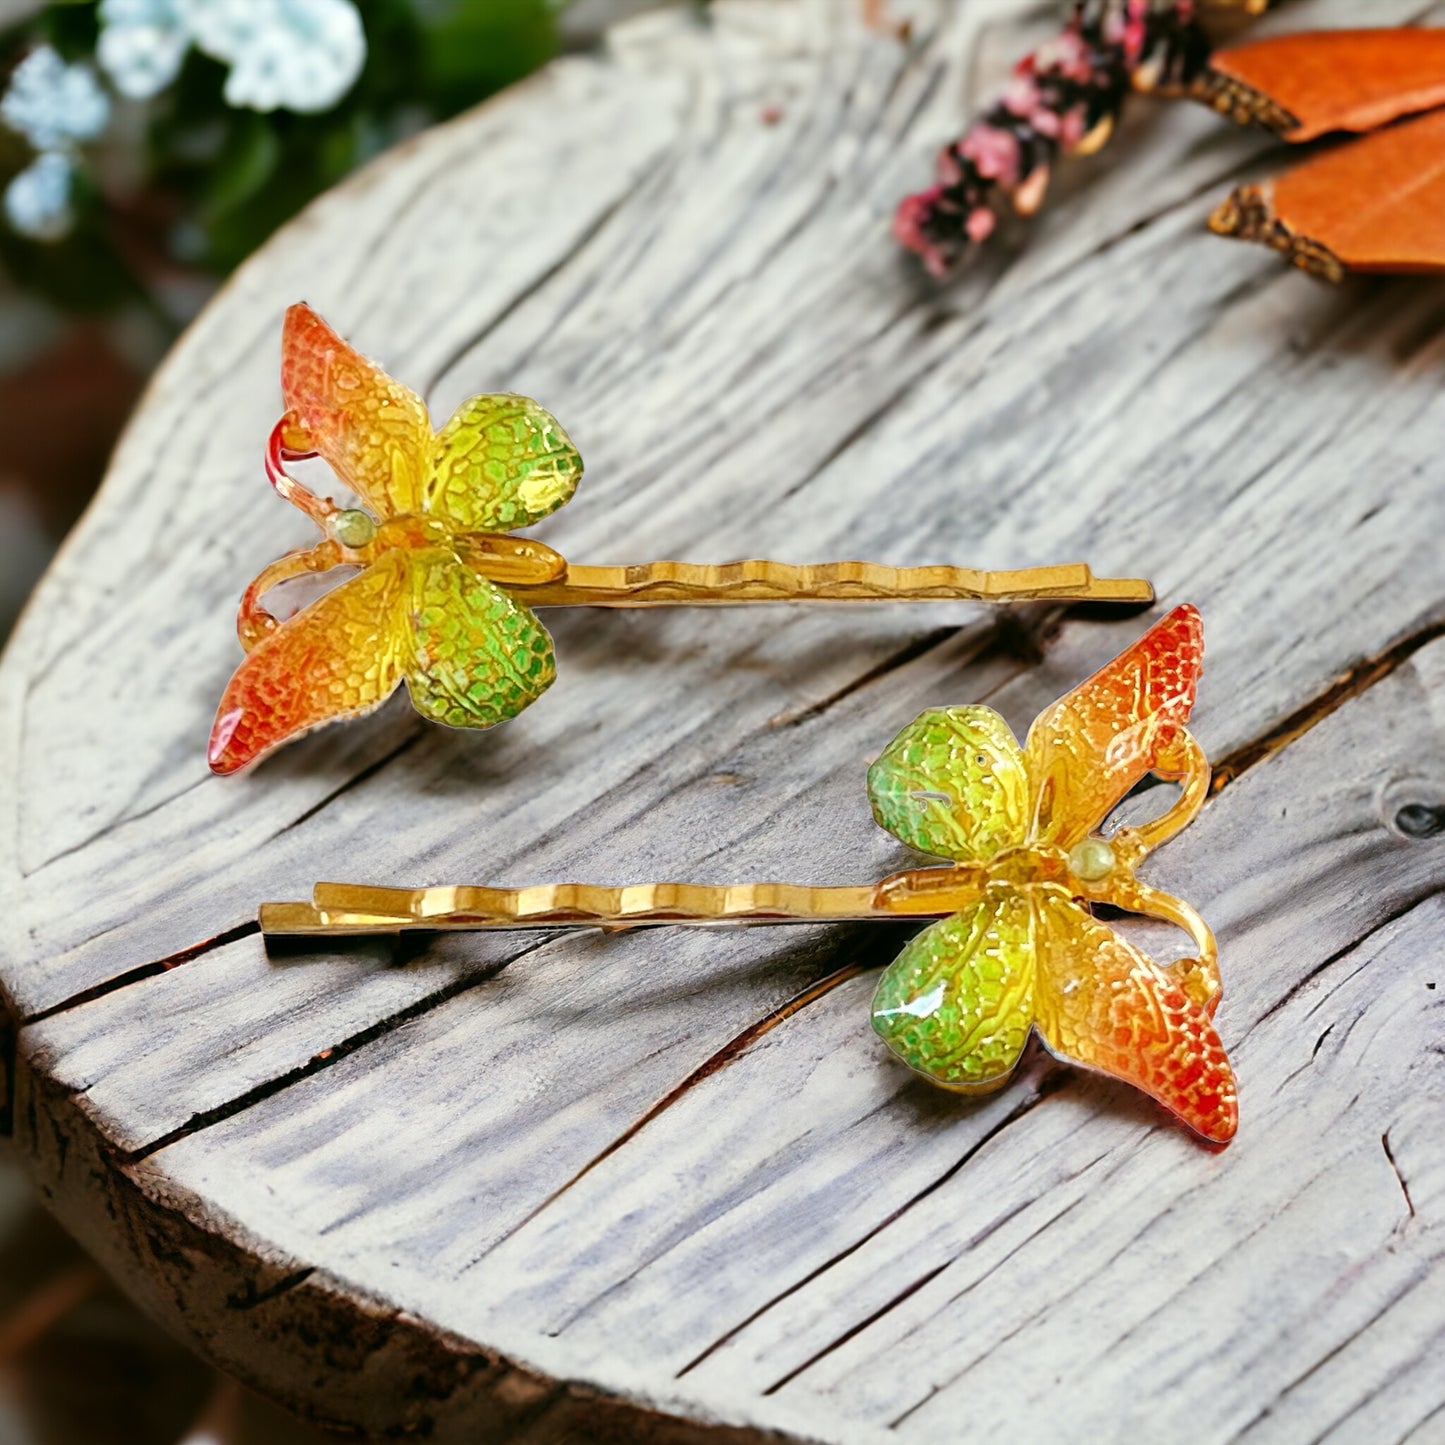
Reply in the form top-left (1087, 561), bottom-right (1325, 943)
top-left (210, 305), bottom-right (582, 773)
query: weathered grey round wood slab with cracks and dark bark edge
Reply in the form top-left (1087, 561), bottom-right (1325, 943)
top-left (0, 0), bottom-right (1445, 1442)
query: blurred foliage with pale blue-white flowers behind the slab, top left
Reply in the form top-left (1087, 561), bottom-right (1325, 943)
top-left (0, 0), bottom-right (661, 638)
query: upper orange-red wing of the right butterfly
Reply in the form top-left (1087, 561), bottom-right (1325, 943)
top-left (1023, 603), bottom-right (1204, 848)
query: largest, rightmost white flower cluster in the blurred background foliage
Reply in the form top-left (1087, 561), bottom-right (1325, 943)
top-left (178, 0), bottom-right (366, 111)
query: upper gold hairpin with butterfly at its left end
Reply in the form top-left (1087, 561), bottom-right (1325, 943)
top-left (208, 305), bottom-right (1153, 773)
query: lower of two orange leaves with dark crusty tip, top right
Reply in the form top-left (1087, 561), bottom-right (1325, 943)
top-left (1209, 110), bottom-right (1445, 280)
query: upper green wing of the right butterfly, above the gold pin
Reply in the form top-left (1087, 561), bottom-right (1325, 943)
top-left (868, 704), bottom-right (1029, 863)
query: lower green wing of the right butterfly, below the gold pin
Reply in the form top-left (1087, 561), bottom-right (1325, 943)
top-left (873, 890), bottom-right (1035, 1092)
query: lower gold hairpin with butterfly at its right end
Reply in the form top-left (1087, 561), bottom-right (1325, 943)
top-left (260, 605), bottom-right (1238, 1144)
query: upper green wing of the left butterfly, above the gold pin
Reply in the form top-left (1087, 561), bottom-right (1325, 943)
top-left (422, 394), bottom-right (582, 532)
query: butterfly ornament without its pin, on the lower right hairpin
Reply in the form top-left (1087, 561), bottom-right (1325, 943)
top-left (868, 607), bottom-right (1238, 1143)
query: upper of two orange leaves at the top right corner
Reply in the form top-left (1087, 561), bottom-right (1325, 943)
top-left (1199, 26), bottom-right (1445, 142)
